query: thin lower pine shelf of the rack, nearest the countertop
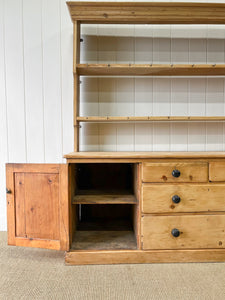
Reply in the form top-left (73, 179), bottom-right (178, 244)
top-left (76, 116), bottom-right (225, 123)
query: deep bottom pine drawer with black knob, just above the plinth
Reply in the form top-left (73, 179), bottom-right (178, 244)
top-left (141, 215), bottom-right (225, 250)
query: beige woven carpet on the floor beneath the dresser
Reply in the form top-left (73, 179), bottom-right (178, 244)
top-left (0, 232), bottom-right (225, 300)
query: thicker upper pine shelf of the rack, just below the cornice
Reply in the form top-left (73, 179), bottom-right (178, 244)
top-left (74, 64), bottom-right (225, 76)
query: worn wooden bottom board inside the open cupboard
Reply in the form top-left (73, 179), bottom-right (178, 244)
top-left (71, 230), bottom-right (137, 250)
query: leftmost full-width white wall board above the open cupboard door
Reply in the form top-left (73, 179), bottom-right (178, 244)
top-left (4, 0), bottom-right (27, 162)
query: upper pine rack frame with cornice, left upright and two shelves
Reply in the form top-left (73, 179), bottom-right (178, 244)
top-left (65, 1), bottom-right (225, 152)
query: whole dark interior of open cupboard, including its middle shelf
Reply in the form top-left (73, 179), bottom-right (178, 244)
top-left (70, 163), bottom-right (139, 250)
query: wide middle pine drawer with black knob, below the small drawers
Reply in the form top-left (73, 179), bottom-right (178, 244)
top-left (142, 183), bottom-right (225, 213)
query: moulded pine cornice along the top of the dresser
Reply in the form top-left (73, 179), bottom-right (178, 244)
top-left (67, 1), bottom-right (225, 24)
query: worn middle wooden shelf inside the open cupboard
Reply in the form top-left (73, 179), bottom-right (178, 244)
top-left (72, 190), bottom-right (137, 204)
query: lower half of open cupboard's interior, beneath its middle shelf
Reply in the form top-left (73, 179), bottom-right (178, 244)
top-left (70, 204), bottom-right (138, 251)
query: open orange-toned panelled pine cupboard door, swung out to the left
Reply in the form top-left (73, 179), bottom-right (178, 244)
top-left (6, 164), bottom-right (69, 250)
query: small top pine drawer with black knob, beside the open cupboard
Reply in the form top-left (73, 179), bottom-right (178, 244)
top-left (142, 162), bottom-right (208, 182)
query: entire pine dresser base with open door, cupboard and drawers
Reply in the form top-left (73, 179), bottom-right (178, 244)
top-left (6, 153), bottom-right (225, 265)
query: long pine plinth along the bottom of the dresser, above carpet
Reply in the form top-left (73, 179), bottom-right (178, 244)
top-left (65, 249), bottom-right (225, 265)
